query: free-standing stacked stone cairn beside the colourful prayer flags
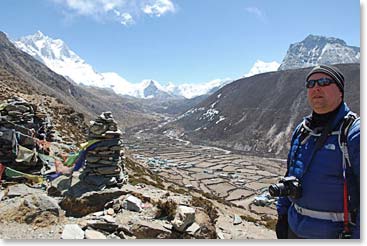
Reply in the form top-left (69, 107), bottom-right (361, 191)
top-left (80, 112), bottom-right (127, 188)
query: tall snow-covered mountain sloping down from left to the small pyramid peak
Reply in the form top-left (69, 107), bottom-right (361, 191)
top-left (14, 31), bottom-right (154, 98)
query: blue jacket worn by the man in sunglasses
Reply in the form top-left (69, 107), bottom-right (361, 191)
top-left (277, 103), bottom-right (360, 239)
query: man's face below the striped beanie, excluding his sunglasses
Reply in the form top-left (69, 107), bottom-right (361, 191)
top-left (307, 73), bottom-right (342, 114)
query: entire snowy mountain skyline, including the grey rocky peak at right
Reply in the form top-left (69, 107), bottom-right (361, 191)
top-left (14, 31), bottom-right (360, 99)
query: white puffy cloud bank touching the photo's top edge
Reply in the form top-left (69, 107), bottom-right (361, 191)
top-left (51, 0), bottom-right (175, 26)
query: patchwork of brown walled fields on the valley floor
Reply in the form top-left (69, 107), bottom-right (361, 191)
top-left (124, 130), bottom-right (286, 216)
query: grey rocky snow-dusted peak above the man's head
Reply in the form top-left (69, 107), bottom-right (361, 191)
top-left (278, 35), bottom-right (360, 70)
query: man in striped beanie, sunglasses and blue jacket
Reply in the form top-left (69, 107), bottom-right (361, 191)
top-left (276, 65), bottom-right (360, 239)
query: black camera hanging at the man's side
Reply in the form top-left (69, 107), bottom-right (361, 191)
top-left (269, 176), bottom-right (302, 199)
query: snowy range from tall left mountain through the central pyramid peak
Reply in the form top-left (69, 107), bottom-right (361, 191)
top-left (13, 31), bottom-right (232, 99)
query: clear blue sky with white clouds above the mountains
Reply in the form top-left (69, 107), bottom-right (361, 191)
top-left (0, 0), bottom-right (360, 84)
